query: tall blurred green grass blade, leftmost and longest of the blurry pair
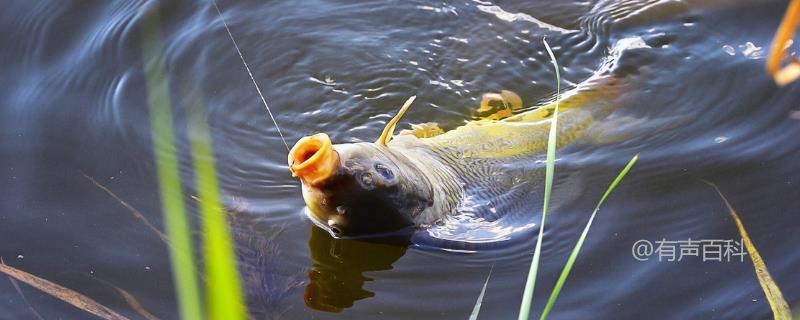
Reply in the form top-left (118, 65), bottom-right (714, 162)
top-left (141, 10), bottom-right (203, 319)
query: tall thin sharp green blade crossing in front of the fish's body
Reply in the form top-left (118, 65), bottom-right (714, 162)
top-left (519, 39), bottom-right (561, 320)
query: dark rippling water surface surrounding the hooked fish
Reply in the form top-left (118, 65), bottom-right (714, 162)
top-left (0, 1), bottom-right (800, 319)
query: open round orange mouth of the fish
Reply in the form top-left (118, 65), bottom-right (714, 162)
top-left (289, 133), bottom-right (339, 186)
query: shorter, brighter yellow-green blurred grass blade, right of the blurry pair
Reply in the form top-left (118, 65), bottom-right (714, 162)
top-left (190, 108), bottom-right (246, 320)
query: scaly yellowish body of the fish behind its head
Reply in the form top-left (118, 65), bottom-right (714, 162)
top-left (388, 77), bottom-right (618, 226)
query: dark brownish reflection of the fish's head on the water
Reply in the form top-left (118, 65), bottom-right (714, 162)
top-left (305, 227), bottom-right (408, 312)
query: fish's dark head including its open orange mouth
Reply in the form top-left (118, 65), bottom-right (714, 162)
top-left (289, 133), bottom-right (433, 238)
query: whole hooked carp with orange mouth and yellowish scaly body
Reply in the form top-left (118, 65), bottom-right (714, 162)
top-left (289, 75), bottom-right (620, 237)
